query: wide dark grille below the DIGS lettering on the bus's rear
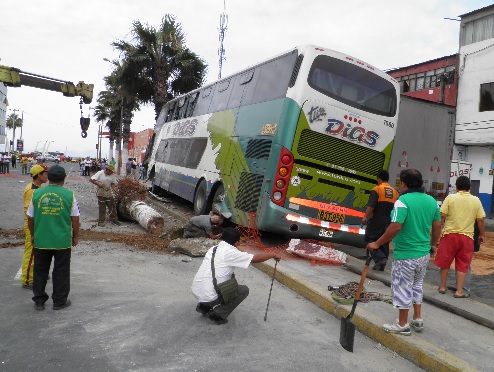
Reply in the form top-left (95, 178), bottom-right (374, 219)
top-left (297, 129), bottom-right (386, 177)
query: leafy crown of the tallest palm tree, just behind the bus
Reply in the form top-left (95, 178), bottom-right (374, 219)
top-left (112, 14), bottom-right (207, 118)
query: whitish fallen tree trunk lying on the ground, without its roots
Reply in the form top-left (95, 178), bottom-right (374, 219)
top-left (117, 198), bottom-right (165, 235)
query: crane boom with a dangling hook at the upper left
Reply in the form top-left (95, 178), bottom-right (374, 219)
top-left (0, 65), bottom-right (94, 138)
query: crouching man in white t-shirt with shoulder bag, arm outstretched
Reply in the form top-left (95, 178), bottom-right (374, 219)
top-left (192, 227), bottom-right (281, 324)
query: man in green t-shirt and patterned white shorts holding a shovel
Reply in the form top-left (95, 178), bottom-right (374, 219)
top-left (367, 169), bottom-right (441, 336)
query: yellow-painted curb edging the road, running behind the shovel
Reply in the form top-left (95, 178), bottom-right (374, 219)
top-left (253, 263), bottom-right (476, 372)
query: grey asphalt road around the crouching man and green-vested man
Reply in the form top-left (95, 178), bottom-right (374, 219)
top-left (0, 164), bottom-right (419, 371)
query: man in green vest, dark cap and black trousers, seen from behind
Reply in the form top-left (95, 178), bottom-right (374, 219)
top-left (27, 165), bottom-right (80, 310)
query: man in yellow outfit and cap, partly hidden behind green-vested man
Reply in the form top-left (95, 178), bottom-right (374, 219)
top-left (21, 164), bottom-right (48, 289)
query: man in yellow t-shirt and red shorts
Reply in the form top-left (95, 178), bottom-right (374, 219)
top-left (434, 176), bottom-right (485, 298)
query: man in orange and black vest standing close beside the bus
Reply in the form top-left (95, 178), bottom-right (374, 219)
top-left (362, 170), bottom-right (399, 271)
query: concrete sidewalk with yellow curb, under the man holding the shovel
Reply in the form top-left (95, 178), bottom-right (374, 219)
top-left (246, 246), bottom-right (494, 371)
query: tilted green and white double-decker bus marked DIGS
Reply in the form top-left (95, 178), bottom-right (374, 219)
top-left (149, 46), bottom-right (399, 246)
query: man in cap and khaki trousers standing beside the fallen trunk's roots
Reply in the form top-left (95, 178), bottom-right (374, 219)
top-left (89, 164), bottom-right (120, 226)
